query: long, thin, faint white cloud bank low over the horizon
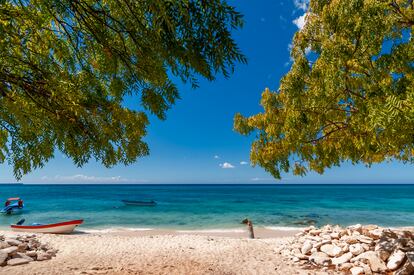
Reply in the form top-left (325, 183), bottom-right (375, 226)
top-left (41, 174), bottom-right (148, 183)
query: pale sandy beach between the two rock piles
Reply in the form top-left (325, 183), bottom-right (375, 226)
top-left (0, 228), bottom-right (330, 275)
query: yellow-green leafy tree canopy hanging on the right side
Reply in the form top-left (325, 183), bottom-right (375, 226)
top-left (234, 0), bottom-right (414, 178)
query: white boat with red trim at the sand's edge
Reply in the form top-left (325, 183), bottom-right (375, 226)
top-left (10, 220), bottom-right (83, 234)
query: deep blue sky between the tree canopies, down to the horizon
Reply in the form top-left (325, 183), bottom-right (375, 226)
top-left (0, 0), bottom-right (414, 183)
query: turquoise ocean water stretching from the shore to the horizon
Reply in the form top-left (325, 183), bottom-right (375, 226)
top-left (0, 184), bottom-right (414, 230)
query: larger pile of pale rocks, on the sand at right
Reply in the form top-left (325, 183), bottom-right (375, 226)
top-left (278, 224), bottom-right (414, 275)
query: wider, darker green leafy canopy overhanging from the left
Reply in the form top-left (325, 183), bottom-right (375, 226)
top-left (0, 0), bottom-right (246, 178)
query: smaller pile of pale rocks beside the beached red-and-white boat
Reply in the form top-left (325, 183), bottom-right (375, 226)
top-left (0, 235), bottom-right (57, 266)
